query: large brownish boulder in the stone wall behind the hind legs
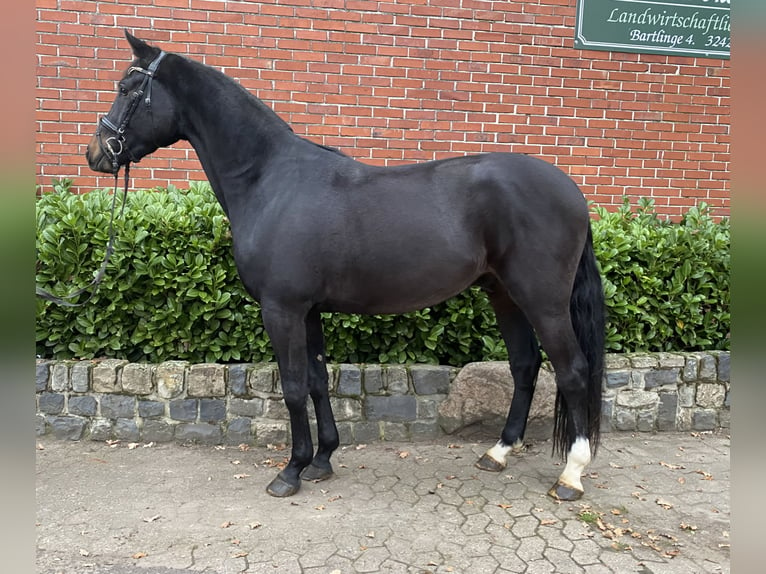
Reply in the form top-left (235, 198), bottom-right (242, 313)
top-left (438, 361), bottom-right (556, 435)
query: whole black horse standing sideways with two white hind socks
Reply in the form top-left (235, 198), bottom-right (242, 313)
top-left (86, 32), bottom-right (604, 500)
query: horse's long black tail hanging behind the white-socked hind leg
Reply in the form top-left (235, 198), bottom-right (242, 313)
top-left (553, 225), bottom-right (606, 455)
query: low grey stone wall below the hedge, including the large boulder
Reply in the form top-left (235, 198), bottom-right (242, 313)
top-left (35, 352), bottom-right (730, 445)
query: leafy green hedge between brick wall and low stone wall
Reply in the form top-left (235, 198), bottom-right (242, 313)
top-left (37, 182), bottom-right (730, 365)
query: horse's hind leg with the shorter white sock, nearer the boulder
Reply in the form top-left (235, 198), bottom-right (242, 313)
top-left (476, 281), bottom-right (542, 471)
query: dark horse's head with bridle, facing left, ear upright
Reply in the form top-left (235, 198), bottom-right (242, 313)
top-left (85, 31), bottom-right (179, 173)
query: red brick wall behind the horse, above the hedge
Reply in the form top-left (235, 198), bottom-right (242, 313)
top-left (36, 0), bottom-right (730, 215)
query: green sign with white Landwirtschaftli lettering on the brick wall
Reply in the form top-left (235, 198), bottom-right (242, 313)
top-left (575, 0), bottom-right (731, 59)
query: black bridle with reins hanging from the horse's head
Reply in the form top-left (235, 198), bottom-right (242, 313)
top-left (35, 52), bottom-right (165, 307)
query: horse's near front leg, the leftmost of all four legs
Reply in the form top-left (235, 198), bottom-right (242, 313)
top-left (261, 303), bottom-right (314, 497)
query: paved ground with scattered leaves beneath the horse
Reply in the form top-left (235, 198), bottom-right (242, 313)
top-left (36, 433), bottom-right (730, 574)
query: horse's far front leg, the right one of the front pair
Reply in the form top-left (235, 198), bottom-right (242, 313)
top-left (301, 309), bottom-right (340, 482)
